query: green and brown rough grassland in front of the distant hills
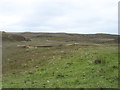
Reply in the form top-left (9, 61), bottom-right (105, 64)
top-left (3, 32), bottom-right (118, 88)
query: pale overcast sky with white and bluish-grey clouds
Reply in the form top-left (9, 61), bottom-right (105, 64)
top-left (0, 0), bottom-right (119, 34)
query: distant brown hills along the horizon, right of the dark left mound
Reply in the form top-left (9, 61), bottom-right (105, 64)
top-left (19, 32), bottom-right (118, 44)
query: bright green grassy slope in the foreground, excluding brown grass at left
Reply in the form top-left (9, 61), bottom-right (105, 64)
top-left (3, 45), bottom-right (118, 88)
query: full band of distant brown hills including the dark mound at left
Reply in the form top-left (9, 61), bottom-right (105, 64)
top-left (3, 32), bottom-right (118, 44)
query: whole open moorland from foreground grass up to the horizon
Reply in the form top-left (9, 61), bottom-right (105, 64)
top-left (3, 32), bottom-right (119, 88)
